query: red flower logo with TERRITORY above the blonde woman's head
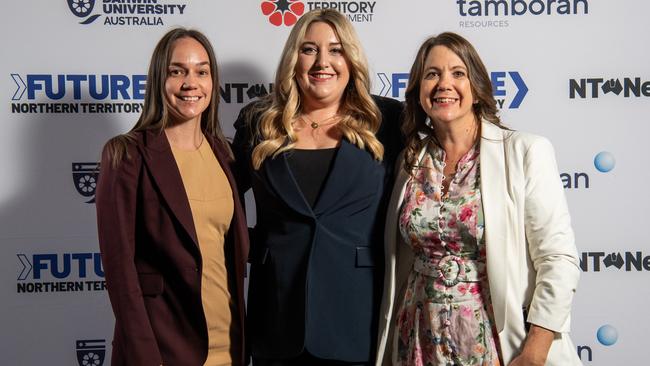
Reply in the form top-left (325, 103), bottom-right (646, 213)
top-left (260, 0), bottom-right (377, 27)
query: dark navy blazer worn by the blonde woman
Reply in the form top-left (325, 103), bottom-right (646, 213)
top-left (233, 96), bottom-right (402, 362)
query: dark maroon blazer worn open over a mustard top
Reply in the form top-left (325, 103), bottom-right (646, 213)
top-left (96, 131), bottom-right (249, 366)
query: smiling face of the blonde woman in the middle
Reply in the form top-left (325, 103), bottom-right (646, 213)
top-left (295, 22), bottom-right (350, 107)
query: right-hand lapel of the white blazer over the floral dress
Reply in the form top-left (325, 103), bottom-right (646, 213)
top-left (479, 122), bottom-right (510, 332)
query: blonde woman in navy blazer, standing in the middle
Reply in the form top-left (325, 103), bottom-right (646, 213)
top-left (233, 10), bottom-right (401, 366)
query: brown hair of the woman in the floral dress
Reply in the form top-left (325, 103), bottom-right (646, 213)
top-left (402, 32), bottom-right (504, 173)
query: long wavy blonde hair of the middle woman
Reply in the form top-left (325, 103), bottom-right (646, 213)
top-left (252, 9), bottom-right (384, 169)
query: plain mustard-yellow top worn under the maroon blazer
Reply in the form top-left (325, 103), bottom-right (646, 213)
top-left (172, 138), bottom-right (239, 366)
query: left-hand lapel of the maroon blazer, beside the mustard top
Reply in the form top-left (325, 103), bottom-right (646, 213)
top-left (142, 130), bottom-right (198, 246)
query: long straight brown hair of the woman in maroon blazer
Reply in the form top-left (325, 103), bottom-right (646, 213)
top-left (107, 27), bottom-right (233, 166)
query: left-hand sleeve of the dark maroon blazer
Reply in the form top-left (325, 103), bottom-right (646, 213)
top-left (96, 142), bottom-right (162, 365)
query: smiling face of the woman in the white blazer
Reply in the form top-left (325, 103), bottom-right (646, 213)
top-left (420, 46), bottom-right (475, 128)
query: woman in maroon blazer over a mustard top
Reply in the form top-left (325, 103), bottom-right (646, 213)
top-left (97, 28), bottom-right (248, 366)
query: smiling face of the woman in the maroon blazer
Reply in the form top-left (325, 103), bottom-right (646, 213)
top-left (165, 37), bottom-right (212, 124)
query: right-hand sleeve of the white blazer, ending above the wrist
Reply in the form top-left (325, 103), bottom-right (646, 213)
top-left (524, 137), bottom-right (580, 332)
